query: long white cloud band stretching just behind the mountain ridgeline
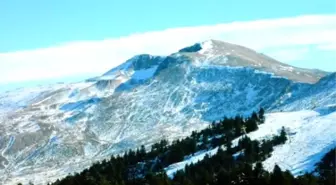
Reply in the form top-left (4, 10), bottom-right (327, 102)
top-left (0, 15), bottom-right (336, 83)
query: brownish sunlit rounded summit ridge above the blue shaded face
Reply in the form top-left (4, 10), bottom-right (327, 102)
top-left (179, 40), bottom-right (327, 83)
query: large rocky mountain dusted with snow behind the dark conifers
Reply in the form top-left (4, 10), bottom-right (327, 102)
top-left (0, 40), bottom-right (336, 184)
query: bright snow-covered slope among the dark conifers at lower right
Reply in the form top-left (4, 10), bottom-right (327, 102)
top-left (165, 110), bottom-right (336, 177)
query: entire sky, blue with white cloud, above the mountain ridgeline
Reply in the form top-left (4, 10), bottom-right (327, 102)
top-left (0, 0), bottom-right (336, 87)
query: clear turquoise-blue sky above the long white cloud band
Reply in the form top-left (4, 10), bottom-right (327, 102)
top-left (0, 0), bottom-right (336, 52)
